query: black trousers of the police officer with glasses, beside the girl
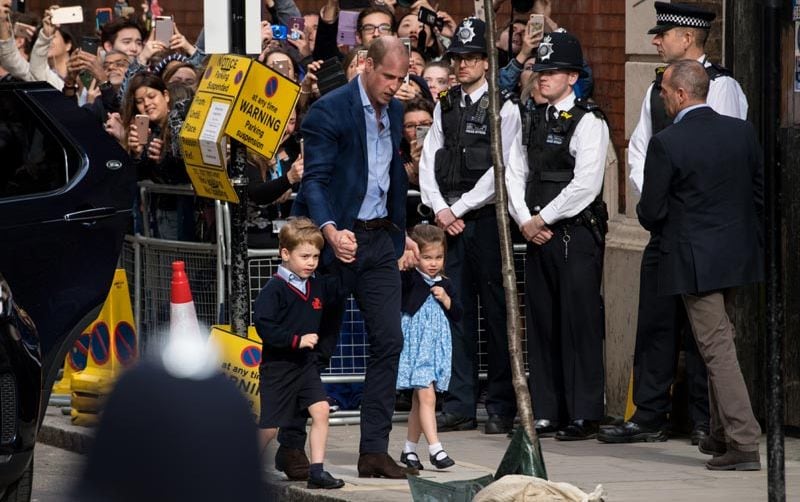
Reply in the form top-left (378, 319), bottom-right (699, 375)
top-left (442, 215), bottom-right (517, 417)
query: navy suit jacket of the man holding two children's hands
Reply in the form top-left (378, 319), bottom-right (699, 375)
top-left (292, 77), bottom-right (408, 264)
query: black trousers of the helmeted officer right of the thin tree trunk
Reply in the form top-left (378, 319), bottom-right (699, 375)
top-left (525, 225), bottom-right (605, 423)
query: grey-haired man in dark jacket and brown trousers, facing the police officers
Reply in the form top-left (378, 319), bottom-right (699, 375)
top-left (636, 60), bottom-right (764, 470)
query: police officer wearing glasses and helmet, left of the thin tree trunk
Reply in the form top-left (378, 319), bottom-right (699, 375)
top-left (419, 18), bottom-right (520, 434)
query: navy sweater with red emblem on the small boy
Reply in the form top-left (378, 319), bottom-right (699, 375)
top-left (253, 275), bottom-right (332, 361)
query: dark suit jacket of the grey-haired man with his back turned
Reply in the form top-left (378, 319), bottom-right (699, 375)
top-left (636, 107), bottom-right (764, 295)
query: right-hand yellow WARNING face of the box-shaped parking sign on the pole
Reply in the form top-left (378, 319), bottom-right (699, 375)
top-left (225, 63), bottom-right (300, 158)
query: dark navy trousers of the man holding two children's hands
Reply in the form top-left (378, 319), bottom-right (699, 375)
top-left (278, 229), bottom-right (403, 453)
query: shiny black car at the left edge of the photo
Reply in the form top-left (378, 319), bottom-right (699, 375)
top-left (0, 83), bottom-right (136, 501)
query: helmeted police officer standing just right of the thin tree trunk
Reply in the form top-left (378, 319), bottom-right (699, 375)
top-left (506, 32), bottom-right (609, 440)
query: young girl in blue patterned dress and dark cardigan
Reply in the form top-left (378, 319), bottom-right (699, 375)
top-left (397, 223), bottom-right (461, 469)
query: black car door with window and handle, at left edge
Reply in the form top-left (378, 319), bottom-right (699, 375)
top-left (0, 83), bottom-right (136, 389)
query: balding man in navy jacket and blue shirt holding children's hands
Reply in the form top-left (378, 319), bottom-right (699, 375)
top-left (282, 37), bottom-right (418, 478)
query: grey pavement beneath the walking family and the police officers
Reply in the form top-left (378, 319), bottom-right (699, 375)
top-left (40, 406), bottom-right (800, 502)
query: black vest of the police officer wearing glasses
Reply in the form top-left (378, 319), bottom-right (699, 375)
top-left (434, 86), bottom-right (492, 204)
